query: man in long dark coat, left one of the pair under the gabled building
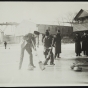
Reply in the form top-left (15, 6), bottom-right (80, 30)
top-left (74, 33), bottom-right (81, 56)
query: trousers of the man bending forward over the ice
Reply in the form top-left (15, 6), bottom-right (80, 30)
top-left (19, 44), bottom-right (34, 69)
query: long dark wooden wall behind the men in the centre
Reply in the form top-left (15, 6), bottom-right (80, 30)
top-left (37, 24), bottom-right (73, 36)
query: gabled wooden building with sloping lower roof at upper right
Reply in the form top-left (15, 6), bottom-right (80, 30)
top-left (73, 9), bottom-right (88, 34)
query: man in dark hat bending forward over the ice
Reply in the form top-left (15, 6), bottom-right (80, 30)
top-left (19, 31), bottom-right (39, 69)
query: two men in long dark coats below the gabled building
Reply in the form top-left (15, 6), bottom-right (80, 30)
top-left (74, 32), bottom-right (88, 56)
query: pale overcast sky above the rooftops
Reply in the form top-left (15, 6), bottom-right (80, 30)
top-left (0, 2), bottom-right (88, 23)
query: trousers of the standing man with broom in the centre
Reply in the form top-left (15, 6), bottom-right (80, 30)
top-left (44, 49), bottom-right (54, 64)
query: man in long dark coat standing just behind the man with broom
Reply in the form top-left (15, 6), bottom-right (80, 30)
top-left (53, 30), bottom-right (61, 58)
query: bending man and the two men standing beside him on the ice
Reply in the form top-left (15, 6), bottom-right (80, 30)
top-left (19, 30), bottom-right (61, 69)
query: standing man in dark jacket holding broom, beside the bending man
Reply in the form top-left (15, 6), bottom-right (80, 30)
top-left (43, 32), bottom-right (55, 65)
